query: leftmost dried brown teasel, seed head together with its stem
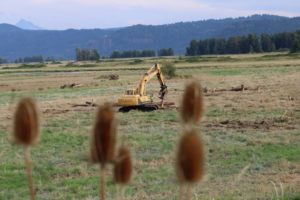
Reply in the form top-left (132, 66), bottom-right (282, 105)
top-left (13, 98), bottom-right (39, 200)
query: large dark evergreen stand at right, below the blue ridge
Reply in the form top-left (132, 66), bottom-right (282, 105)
top-left (186, 30), bottom-right (300, 56)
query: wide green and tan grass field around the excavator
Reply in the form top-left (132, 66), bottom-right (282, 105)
top-left (0, 53), bottom-right (300, 200)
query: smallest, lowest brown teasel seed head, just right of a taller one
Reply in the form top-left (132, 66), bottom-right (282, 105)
top-left (114, 146), bottom-right (132, 185)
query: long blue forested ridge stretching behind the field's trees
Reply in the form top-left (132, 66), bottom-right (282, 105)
top-left (0, 15), bottom-right (300, 60)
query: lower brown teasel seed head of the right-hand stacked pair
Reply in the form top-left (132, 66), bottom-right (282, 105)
top-left (176, 131), bottom-right (204, 183)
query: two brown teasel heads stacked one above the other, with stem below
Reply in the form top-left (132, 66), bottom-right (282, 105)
top-left (176, 80), bottom-right (204, 199)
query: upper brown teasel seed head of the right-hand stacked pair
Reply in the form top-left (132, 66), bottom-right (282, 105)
top-left (181, 80), bottom-right (203, 124)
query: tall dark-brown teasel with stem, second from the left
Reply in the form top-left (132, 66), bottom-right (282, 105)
top-left (91, 103), bottom-right (116, 200)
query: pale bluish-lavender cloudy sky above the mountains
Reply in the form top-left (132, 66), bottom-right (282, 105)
top-left (0, 0), bottom-right (300, 30)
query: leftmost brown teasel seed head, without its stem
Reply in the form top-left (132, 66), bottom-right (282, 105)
top-left (14, 98), bottom-right (39, 146)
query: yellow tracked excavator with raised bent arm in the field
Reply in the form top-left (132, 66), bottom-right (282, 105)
top-left (117, 64), bottom-right (168, 112)
